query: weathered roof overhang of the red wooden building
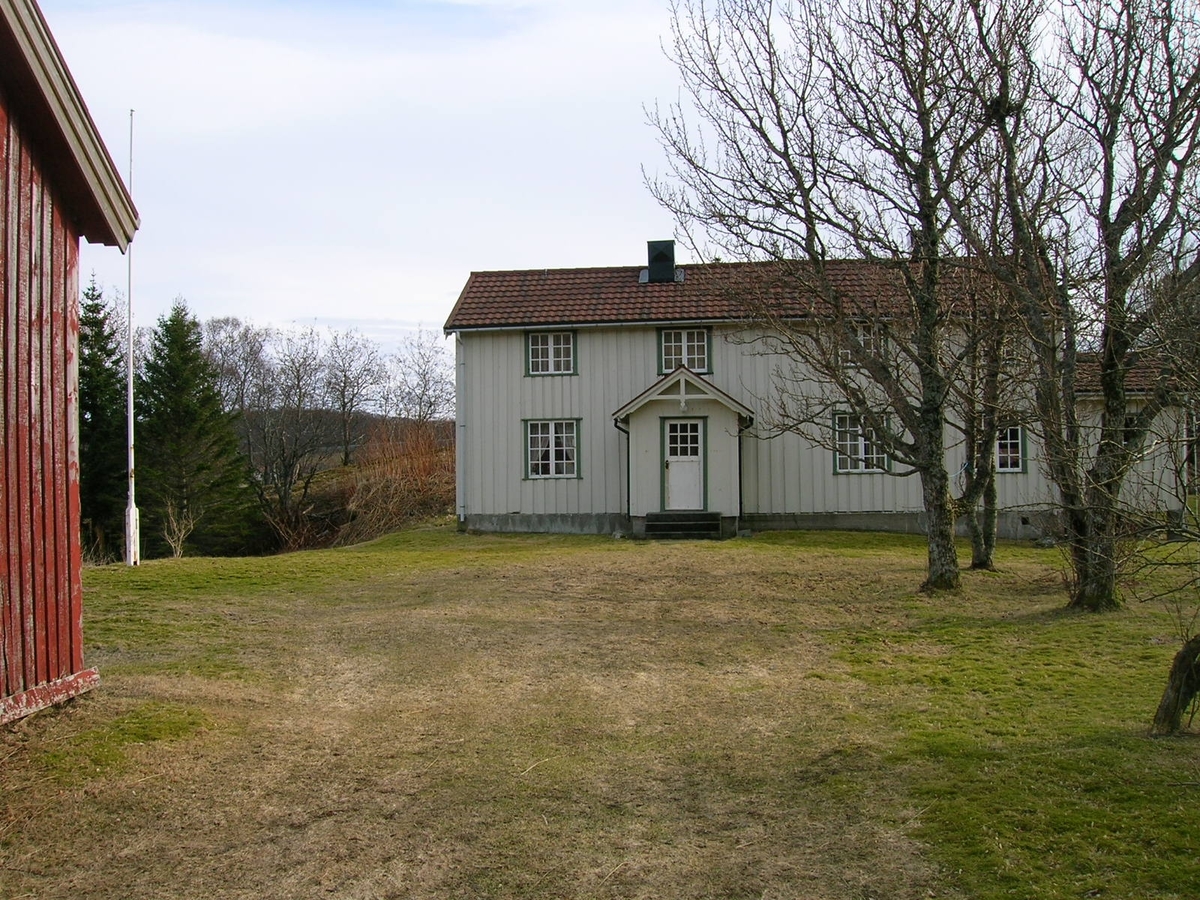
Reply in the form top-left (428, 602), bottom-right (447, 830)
top-left (0, 0), bottom-right (139, 252)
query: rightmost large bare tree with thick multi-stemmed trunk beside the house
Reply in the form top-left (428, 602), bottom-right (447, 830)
top-left (955, 0), bottom-right (1200, 611)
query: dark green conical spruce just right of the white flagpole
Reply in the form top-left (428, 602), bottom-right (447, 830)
top-left (137, 299), bottom-right (252, 556)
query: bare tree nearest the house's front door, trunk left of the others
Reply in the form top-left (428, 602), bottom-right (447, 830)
top-left (650, 0), bottom-right (1008, 589)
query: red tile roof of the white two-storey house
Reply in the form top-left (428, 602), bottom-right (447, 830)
top-left (445, 260), bottom-right (940, 331)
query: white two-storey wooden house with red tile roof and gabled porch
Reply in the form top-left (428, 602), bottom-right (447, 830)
top-left (445, 241), bottom-right (1190, 538)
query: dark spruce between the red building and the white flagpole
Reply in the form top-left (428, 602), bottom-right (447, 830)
top-left (79, 277), bottom-right (128, 562)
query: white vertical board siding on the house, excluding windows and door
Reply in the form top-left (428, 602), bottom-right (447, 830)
top-left (456, 325), bottom-right (1182, 516)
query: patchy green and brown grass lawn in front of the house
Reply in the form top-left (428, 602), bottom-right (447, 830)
top-left (0, 527), bottom-right (1200, 900)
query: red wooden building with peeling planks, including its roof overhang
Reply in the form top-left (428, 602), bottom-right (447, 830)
top-left (0, 0), bottom-right (138, 722)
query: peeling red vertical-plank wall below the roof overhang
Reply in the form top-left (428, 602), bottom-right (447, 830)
top-left (0, 77), bottom-right (97, 722)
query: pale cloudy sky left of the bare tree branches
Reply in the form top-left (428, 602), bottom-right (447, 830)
top-left (40, 0), bottom-right (679, 349)
